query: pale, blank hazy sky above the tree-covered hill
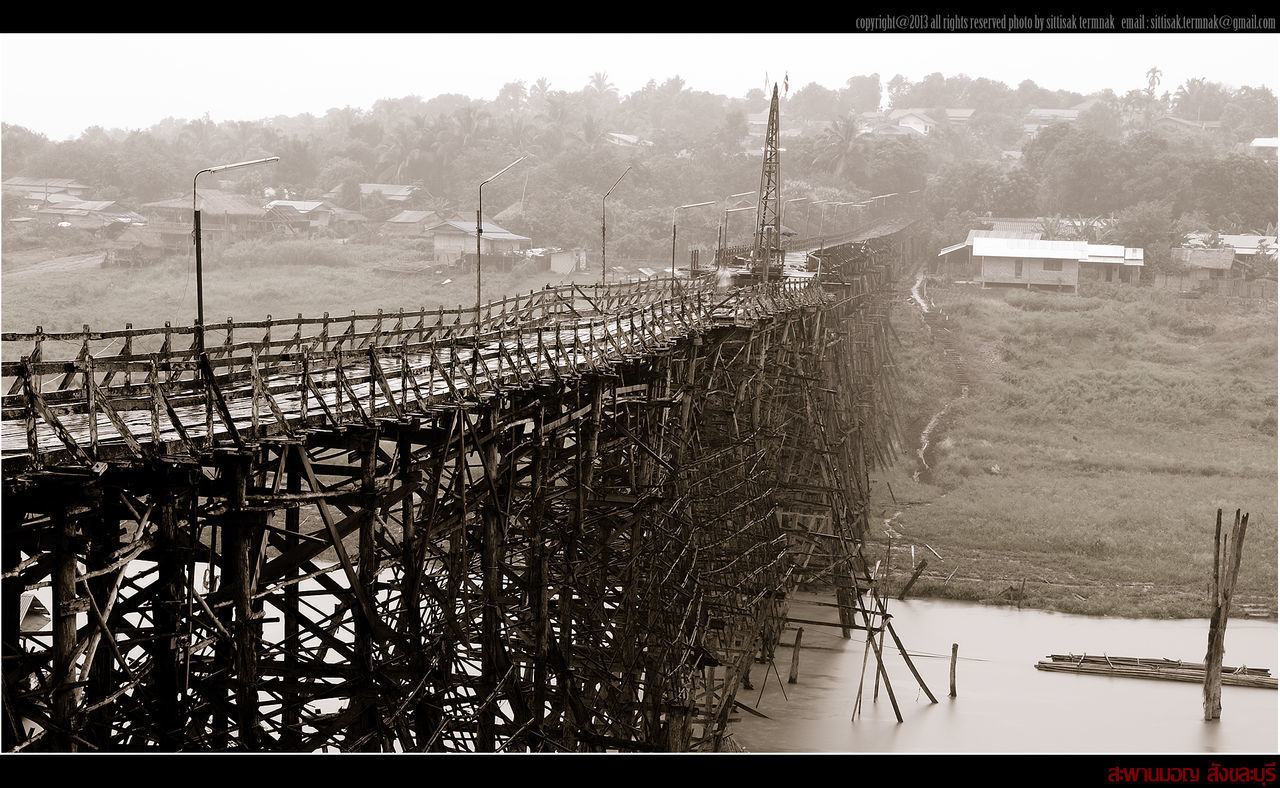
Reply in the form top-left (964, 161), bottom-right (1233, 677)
top-left (0, 33), bottom-right (1280, 139)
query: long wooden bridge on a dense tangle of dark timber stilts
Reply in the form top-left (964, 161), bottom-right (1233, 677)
top-left (0, 227), bottom-right (921, 752)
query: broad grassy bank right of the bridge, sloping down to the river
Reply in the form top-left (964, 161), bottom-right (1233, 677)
top-left (870, 281), bottom-right (1277, 618)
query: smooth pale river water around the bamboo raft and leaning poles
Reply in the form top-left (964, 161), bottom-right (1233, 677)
top-left (730, 594), bottom-right (1280, 755)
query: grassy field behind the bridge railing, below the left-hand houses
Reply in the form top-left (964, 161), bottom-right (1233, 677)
top-left (0, 234), bottom-right (611, 331)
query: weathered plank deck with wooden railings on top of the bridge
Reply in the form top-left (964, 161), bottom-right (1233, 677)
top-left (0, 279), bottom-right (826, 472)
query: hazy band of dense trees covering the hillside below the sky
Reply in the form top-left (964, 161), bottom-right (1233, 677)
top-left (0, 68), bottom-right (1276, 264)
